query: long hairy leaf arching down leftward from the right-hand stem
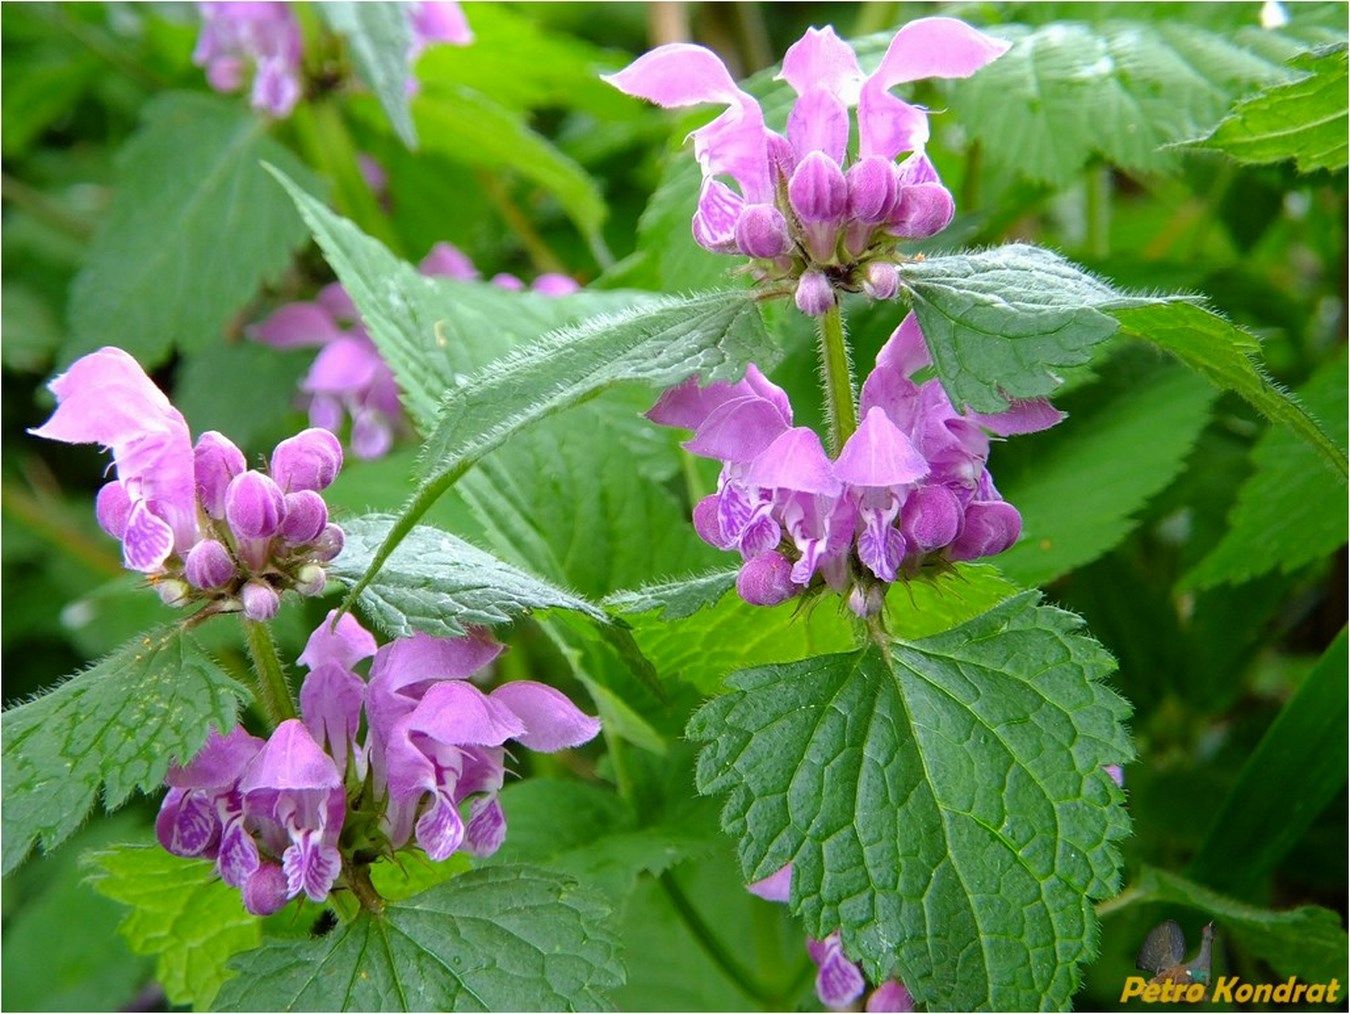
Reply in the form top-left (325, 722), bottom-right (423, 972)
top-left (348, 292), bottom-right (778, 599)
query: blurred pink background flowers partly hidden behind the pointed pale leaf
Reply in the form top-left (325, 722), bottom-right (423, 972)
top-left (248, 243), bottom-right (581, 459)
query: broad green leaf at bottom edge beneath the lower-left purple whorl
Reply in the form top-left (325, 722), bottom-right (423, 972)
top-left (216, 867), bottom-right (624, 1010)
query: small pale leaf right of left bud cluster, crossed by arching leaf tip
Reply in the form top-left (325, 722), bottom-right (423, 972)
top-left (328, 514), bottom-right (606, 637)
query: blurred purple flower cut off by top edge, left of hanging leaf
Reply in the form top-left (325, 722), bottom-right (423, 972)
top-left (192, 3), bottom-right (301, 117)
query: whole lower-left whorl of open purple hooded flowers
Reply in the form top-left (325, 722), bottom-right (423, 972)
top-left (155, 613), bottom-right (599, 915)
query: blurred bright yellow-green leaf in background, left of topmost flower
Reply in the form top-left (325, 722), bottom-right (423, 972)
top-left (413, 86), bottom-right (606, 247)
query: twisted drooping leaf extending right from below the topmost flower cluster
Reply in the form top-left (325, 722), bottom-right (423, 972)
top-left (900, 243), bottom-right (1346, 474)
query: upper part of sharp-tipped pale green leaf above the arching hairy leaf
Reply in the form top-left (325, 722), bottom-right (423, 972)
top-left (274, 165), bottom-right (651, 433)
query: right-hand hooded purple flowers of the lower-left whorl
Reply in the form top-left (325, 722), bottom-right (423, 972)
top-left (366, 631), bottom-right (599, 860)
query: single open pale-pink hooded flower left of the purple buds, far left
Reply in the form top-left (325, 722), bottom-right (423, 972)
top-left (30, 347), bottom-right (198, 574)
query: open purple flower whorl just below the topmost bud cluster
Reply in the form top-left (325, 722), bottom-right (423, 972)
top-left (648, 315), bottom-right (1062, 616)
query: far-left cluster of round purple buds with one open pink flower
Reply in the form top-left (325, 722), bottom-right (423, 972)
top-left (31, 347), bottom-right (343, 620)
